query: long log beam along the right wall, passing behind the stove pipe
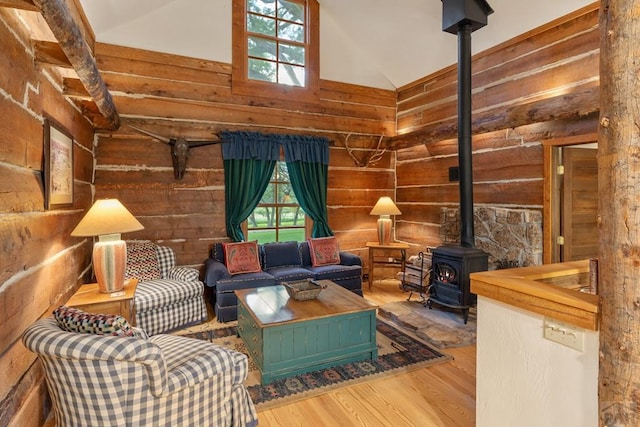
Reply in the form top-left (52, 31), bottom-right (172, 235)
top-left (388, 84), bottom-right (600, 150)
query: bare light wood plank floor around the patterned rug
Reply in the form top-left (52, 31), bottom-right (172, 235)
top-left (258, 283), bottom-right (476, 427)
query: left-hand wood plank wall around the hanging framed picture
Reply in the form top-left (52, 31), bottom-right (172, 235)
top-left (0, 7), bottom-right (93, 426)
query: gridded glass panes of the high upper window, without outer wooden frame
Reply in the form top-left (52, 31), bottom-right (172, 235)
top-left (247, 0), bottom-right (307, 86)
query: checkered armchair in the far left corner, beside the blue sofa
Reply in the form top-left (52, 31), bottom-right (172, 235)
top-left (126, 241), bottom-right (207, 335)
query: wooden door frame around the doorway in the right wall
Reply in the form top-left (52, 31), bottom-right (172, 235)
top-left (542, 132), bottom-right (598, 264)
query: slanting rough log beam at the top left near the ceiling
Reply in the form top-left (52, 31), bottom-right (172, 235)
top-left (33, 0), bottom-right (120, 130)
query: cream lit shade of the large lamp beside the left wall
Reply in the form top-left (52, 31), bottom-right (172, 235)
top-left (71, 199), bottom-right (144, 236)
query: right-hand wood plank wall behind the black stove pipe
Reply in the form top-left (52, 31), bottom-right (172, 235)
top-left (394, 4), bottom-right (599, 252)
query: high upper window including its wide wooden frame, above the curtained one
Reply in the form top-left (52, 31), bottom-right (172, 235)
top-left (232, 0), bottom-right (319, 100)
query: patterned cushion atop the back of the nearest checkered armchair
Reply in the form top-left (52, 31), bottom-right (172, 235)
top-left (53, 305), bottom-right (136, 337)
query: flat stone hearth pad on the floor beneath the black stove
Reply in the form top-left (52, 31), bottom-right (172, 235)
top-left (378, 300), bottom-right (477, 348)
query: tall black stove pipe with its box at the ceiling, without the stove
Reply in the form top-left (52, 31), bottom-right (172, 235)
top-left (442, 0), bottom-right (493, 248)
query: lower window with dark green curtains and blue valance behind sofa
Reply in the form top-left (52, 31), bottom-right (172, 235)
top-left (220, 132), bottom-right (333, 242)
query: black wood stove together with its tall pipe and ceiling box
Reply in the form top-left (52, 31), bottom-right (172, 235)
top-left (426, 0), bottom-right (493, 323)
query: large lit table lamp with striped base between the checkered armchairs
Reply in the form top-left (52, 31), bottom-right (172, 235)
top-left (71, 199), bottom-right (144, 293)
